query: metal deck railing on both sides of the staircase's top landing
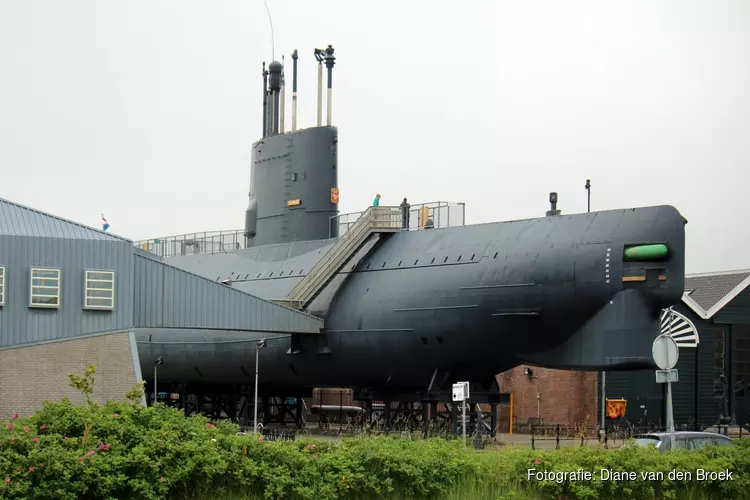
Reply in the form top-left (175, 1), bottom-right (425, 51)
top-left (328, 201), bottom-right (466, 237)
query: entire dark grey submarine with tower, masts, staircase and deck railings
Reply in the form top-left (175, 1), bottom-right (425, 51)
top-left (137, 45), bottom-right (687, 395)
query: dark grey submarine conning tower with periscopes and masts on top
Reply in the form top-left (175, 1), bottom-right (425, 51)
top-left (244, 45), bottom-right (339, 247)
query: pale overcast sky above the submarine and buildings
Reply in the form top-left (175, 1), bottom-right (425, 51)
top-left (0, 0), bottom-right (750, 272)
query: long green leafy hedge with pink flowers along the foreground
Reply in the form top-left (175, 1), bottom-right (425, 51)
top-left (0, 367), bottom-right (750, 500)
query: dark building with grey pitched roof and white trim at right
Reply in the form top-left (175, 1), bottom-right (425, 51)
top-left (606, 270), bottom-right (750, 428)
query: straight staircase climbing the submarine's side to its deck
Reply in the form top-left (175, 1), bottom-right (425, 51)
top-left (286, 207), bottom-right (402, 309)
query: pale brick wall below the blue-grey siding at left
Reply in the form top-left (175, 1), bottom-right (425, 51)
top-left (0, 332), bottom-right (137, 419)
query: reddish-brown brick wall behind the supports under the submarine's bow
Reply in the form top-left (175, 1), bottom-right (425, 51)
top-left (497, 366), bottom-right (597, 431)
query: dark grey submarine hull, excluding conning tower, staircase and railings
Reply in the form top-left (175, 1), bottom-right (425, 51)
top-left (136, 206), bottom-right (686, 393)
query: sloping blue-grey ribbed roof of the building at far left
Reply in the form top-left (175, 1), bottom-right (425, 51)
top-left (0, 198), bottom-right (130, 242)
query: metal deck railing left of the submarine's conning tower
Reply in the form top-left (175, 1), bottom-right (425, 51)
top-left (133, 229), bottom-right (245, 258)
